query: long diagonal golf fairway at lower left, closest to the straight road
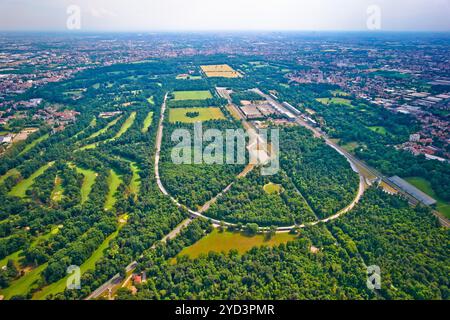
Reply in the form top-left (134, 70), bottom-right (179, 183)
top-left (33, 229), bottom-right (120, 300)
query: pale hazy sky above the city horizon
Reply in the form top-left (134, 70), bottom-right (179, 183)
top-left (0, 0), bottom-right (450, 31)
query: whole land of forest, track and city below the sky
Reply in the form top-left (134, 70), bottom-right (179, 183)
top-left (0, 1), bottom-right (450, 310)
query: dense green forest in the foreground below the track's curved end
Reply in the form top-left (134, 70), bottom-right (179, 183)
top-left (119, 189), bottom-right (449, 300)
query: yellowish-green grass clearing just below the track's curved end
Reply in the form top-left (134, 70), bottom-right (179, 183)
top-left (178, 229), bottom-right (297, 259)
